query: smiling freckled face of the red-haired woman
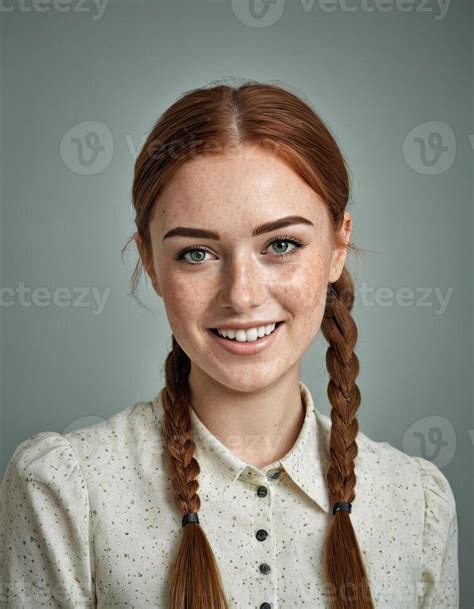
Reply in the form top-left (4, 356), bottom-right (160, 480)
top-left (138, 147), bottom-right (350, 391)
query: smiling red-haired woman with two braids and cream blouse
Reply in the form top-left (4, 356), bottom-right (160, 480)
top-left (0, 82), bottom-right (458, 609)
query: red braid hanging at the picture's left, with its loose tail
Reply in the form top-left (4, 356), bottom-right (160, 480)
top-left (162, 336), bottom-right (229, 609)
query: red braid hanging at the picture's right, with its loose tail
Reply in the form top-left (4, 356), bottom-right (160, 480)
top-left (321, 269), bottom-right (374, 609)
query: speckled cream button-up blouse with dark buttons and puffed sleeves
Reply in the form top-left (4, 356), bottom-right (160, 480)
top-left (0, 382), bottom-right (459, 609)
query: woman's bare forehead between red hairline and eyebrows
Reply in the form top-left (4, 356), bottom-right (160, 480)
top-left (151, 147), bottom-right (328, 238)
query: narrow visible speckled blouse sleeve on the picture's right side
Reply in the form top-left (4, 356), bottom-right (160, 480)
top-left (413, 457), bottom-right (459, 609)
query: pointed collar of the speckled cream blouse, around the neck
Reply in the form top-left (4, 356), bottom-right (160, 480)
top-left (153, 381), bottom-right (331, 512)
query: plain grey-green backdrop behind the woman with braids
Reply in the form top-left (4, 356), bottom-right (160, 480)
top-left (0, 0), bottom-right (474, 609)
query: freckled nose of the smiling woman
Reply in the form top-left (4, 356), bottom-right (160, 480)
top-left (217, 258), bottom-right (266, 311)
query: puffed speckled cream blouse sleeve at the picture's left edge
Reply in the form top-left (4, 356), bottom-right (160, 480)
top-left (0, 431), bottom-right (95, 609)
